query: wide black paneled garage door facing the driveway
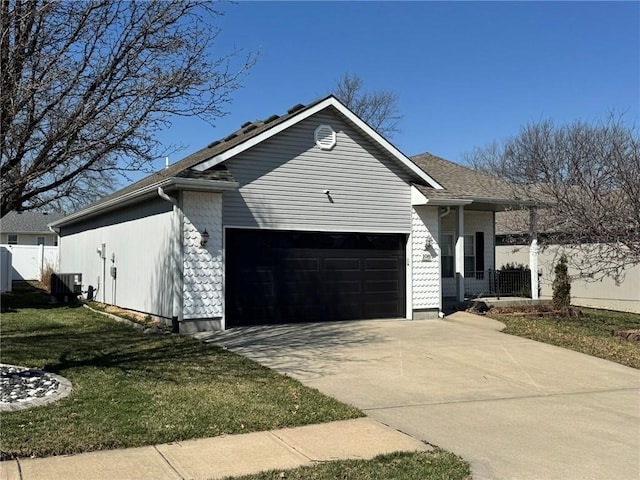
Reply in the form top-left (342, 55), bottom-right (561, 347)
top-left (225, 229), bottom-right (406, 327)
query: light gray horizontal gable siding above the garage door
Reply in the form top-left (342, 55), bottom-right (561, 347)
top-left (223, 112), bottom-right (411, 233)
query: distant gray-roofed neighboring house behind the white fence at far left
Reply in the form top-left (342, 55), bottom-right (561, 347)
top-left (0, 210), bottom-right (63, 246)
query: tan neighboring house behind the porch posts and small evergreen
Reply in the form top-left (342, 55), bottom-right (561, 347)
top-left (496, 210), bottom-right (640, 313)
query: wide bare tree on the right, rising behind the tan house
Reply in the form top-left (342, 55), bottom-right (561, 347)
top-left (466, 115), bottom-right (640, 281)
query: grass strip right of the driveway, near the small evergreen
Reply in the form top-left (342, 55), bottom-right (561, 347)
top-left (487, 309), bottom-right (640, 368)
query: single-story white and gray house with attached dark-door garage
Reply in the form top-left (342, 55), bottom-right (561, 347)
top-left (51, 96), bottom-right (532, 332)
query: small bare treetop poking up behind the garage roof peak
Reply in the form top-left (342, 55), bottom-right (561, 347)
top-left (335, 73), bottom-right (402, 137)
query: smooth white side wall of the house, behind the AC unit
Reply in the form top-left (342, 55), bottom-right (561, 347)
top-left (60, 199), bottom-right (176, 318)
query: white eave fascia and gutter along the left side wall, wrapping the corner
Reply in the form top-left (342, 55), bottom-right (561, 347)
top-left (47, 177), bottom-right (239, 229)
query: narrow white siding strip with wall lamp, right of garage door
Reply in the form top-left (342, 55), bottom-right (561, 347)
top-left (411, 207), bottom-right (440, 309)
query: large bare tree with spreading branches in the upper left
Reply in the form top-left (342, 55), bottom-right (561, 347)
top-left (0, 0), bottom-right (255, 218)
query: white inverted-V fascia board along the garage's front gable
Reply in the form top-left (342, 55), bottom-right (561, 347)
top-left (193, 97), bottom-right (443, 190)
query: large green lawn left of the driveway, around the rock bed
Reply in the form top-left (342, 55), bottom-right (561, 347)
top-left (0, 286), bottom-right (362, 458)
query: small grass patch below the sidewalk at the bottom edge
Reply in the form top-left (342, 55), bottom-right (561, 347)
top-left (227, 449), bottom-right (471, 480)
